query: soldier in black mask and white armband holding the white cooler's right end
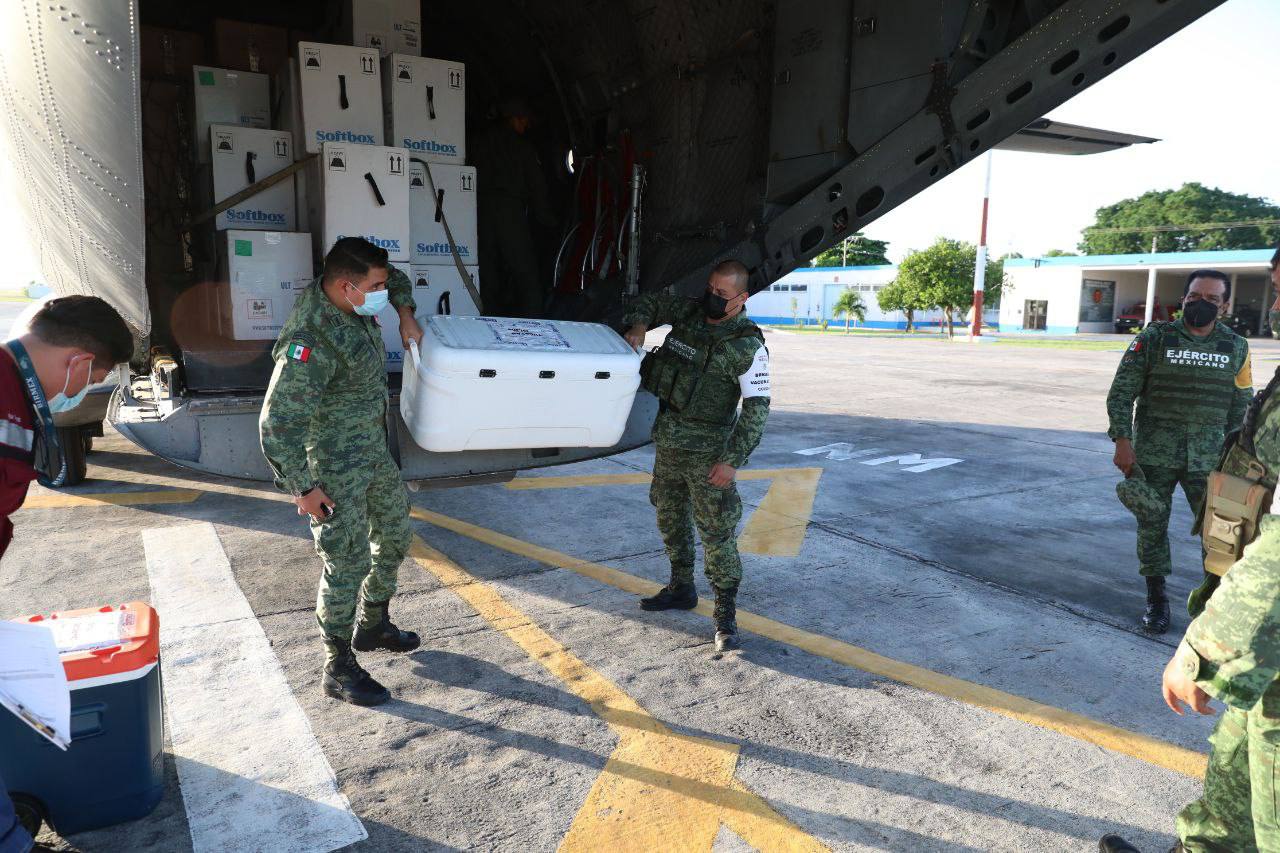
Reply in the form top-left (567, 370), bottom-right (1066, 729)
top-left (625, 261), bottom-right (769, 652)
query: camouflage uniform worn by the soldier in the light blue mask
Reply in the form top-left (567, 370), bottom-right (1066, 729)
top-left (259, 268), bottom-right (415, 654)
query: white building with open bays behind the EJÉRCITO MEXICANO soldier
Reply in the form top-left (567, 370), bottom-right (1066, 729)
top-left (1000, 248), bottom-right (1275, 334)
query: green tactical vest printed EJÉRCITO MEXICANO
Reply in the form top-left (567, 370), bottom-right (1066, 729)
top-left (1142, 320), bottom-right (1244, 425)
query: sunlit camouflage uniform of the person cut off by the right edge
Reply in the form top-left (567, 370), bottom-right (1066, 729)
top-left (1178, 376), bottom-right (1280, 853)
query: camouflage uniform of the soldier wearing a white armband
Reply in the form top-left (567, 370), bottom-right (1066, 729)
top-left (625, 293), bottom-right (769, 590)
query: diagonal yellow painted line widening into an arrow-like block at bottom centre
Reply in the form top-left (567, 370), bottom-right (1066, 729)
top-left (410, 537), bottom-right (827, 852)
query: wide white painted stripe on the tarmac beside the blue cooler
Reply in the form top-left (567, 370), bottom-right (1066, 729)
top-left (142, 523), bottom-right (369, 853)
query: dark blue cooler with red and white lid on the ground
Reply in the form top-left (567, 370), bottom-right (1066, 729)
top-left (0, 602), bottom-right (164, 835)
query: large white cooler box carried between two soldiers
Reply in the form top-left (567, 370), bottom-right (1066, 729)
top-left (401, 316), bottom-right (640, 453)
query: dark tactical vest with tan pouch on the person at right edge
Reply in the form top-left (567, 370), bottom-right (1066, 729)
top-left (1192, 369), bottom-right (1280, 576)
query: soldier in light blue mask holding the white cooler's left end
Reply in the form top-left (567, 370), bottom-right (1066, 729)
top-left (259, 237), bottom-right (422, 704)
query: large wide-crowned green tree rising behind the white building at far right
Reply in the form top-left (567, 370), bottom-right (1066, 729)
top-left (1079, 183), bottom-right (1280, 255)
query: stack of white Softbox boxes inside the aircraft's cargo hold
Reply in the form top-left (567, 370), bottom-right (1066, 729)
top-left (142, 0), bottom-right (479, 370)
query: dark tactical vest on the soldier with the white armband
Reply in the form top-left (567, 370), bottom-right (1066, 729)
top-left (640, 320), bottom-right (764, 427)
